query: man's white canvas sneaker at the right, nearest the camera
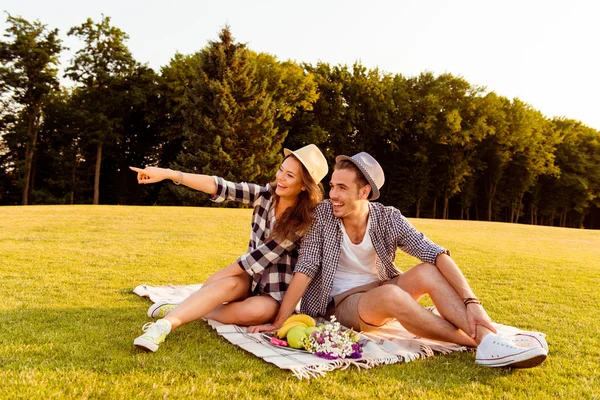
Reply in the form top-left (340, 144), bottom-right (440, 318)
top-left (475, 333), bottom-right (548, 368)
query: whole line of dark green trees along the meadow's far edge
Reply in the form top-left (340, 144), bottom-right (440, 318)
top-left (0, 15), bottom-right (600, 229)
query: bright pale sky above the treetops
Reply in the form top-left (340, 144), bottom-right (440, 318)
top-left (0, 0), bottom-right (600, 130)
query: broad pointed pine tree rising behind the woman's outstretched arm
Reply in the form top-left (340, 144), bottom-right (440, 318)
top-left (172, 27), bottom-right (278, 204)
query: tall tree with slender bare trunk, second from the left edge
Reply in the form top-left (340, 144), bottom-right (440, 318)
top-left (66, 16), bottom-right (135, 204)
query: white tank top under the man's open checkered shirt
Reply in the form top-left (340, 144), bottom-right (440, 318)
top-left (330, 216), bottom-right (379, 297)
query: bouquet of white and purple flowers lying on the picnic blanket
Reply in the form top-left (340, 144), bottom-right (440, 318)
top-left (303, 315), bottom-right (365, 360)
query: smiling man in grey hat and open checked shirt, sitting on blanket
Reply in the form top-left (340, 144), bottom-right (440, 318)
top-left (251, 152), bottom-right (548, 368)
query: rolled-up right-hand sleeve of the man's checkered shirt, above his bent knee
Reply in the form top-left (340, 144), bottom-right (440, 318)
top-left (393, 210), bottom-right (450, 265)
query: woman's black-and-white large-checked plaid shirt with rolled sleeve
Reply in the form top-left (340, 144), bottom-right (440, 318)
top-left (210, 176), bottom-right (300, 302)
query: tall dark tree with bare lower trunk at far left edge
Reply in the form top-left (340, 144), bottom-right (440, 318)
top-left (0, 14), bottom-right (63, 205)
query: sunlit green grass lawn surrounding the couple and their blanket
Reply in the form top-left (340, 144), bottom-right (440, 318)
top-left (0, 206), bottom-right (600, 399)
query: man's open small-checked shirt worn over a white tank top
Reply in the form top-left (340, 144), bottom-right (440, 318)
top-left (294, 200), bottom-right (449, 316)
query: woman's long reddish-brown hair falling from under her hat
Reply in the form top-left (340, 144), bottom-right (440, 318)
top-left (270, 154), bottom-right (324, 240)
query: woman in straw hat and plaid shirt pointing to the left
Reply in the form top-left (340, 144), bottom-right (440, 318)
top-left (130, 144), bottom-right (327, 352)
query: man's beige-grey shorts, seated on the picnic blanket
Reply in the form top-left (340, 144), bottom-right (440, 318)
top-left (325, 275), bottom-right (400, 332)
